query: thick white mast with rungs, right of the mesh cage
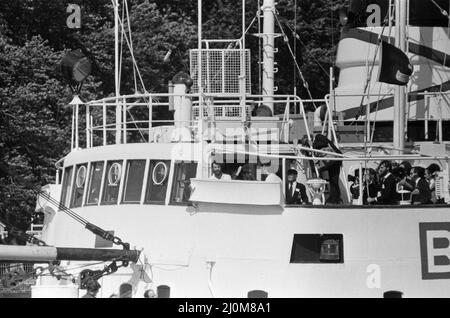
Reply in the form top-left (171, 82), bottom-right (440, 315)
top-left (262, 0), bottom-right (275, 114)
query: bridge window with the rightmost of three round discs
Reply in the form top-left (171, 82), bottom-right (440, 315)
top-left (145, 160), bottom-right (170, 204)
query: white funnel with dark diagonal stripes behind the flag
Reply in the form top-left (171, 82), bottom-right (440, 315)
top-left (335, 26), bottom-right (450, 121)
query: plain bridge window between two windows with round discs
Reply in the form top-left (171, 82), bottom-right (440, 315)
top-left (123, 160), bottom-right (146, 203)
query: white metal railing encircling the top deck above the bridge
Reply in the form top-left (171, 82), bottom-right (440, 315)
top-left (71, 94), bottom-right (309, 149)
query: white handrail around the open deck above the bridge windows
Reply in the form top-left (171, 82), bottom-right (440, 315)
top-left (72, 93), bottom-right (310, 149)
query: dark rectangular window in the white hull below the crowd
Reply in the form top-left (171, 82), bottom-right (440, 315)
top-left (290, 234), bottom-right (344, 263)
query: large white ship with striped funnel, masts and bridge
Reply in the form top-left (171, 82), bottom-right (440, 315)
top-left (27, 0), bottom-right (450, 298)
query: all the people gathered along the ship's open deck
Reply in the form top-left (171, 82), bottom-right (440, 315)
top-left (210, 134), bottom-right (442, 205)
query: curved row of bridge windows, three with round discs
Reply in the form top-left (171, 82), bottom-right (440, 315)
top-left (60, 160), bottom-right (197, 208)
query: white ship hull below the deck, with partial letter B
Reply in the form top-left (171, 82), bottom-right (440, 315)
top-left (41, 196), bottom-right (450, 297)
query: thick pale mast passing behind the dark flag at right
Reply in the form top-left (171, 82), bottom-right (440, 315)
top-left (394, 0), bottom-right (408, 155)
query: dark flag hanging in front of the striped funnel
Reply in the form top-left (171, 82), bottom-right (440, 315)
top-left (378, 41), bottom-right (413, 85)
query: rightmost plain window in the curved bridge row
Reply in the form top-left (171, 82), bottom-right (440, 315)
top-left (170, 162), bottom-right (197, 204)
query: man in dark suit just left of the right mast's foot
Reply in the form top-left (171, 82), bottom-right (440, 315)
top-left (368, 160), bottom-right (398, 205)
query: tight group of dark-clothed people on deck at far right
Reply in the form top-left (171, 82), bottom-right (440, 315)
top-left (349, 160), bottom-right (441, 205)
